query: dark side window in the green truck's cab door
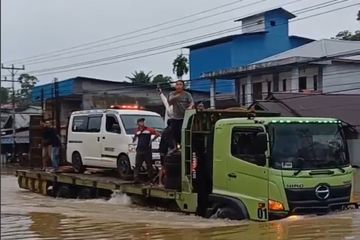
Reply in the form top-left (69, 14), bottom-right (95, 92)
top-left (231, 128), bottom-right (263, 165)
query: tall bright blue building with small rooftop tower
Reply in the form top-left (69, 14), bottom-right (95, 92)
top-left (187, 8), bottom-right (313, 93)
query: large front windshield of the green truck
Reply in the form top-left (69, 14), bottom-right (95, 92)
top-left (269, 123), bottom-right (349, 170)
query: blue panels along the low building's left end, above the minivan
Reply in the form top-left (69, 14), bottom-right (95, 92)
top-left (31, 79), bottom-right (75, 102)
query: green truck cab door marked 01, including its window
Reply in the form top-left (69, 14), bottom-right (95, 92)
top-left (226, 125), bottom-right (268, 221)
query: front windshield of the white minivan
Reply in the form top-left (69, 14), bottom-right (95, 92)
top-left (120, 114), bottom-right (165, 134)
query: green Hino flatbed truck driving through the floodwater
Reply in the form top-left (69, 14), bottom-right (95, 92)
top-left (17, 109), bottom-right (358, 221)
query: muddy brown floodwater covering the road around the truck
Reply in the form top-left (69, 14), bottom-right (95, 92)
top-left (1, 169), bottom-right (360, 240)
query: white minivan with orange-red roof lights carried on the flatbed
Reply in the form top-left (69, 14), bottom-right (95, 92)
top-left (66, 106), bottom-right (165, 179)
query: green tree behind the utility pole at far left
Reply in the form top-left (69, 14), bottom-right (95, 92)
top-left (15, 73), bottom-right (39, 106)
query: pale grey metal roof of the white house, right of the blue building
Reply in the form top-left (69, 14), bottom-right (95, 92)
top-left (253, 39), bottom-right (360, 64)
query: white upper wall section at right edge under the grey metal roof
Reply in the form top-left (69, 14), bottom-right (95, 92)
top-left (323, 62), bottom-right (360, 94)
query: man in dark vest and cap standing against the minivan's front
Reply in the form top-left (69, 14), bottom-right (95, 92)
top-left (133, 118), bottom-right (160, 183)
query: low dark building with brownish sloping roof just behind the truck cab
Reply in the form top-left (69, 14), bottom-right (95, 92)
top-left (251, 93), bottom-right (360, 167)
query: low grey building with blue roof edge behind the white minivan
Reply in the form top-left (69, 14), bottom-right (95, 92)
top-left (32, 77), bottom-right (209, 129)
